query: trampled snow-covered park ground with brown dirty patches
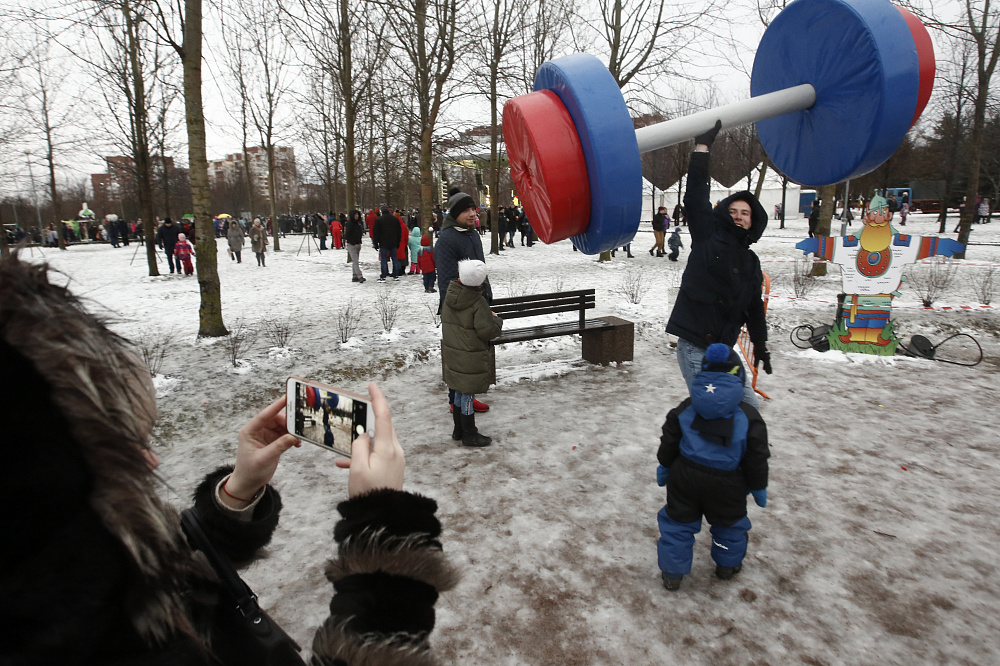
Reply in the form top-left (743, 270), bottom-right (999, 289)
top-left (25, 216), bottom-right (1000, 664)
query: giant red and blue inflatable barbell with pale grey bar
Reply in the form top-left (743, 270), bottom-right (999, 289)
top-left (503, 0), bottom-right (934, 254)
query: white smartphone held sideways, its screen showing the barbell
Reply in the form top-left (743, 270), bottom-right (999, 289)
top-left (293, 380), bottom-right (369, 456)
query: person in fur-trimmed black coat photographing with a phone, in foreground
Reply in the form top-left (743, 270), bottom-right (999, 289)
top-left (0, 253), bottom-right (457, 666)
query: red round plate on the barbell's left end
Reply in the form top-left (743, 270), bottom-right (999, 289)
top-left (503, 90), bottom-right (590, 243)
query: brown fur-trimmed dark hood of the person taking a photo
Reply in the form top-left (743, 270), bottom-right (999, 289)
top-left (0, 254), bottom-right (210, 646)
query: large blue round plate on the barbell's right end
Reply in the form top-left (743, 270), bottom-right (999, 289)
top-left (750, 0), bottom-right (920, 187)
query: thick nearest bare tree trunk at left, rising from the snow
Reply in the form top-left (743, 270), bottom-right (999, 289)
top-left (183, 0), bottom-right (229, 337)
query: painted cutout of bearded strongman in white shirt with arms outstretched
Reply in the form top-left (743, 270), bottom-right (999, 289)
top-left (795, 193), bottom-right (965, 356)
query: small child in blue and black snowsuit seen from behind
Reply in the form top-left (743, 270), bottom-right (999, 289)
top-left (656, 343), bottom-right (770, 590)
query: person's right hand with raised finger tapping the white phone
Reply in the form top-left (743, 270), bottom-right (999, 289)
top-left (337, 382), bottom-right (406, 497)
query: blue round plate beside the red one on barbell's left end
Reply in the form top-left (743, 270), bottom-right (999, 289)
top-left (535, 53), bottom-right (644, 254)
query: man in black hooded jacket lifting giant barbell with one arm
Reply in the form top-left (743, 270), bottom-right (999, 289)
top-left (667, 121), bottom-right (771, 409)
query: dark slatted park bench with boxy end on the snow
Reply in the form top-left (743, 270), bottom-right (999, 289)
top-left (490, 289), bottom-right (635, 384)
